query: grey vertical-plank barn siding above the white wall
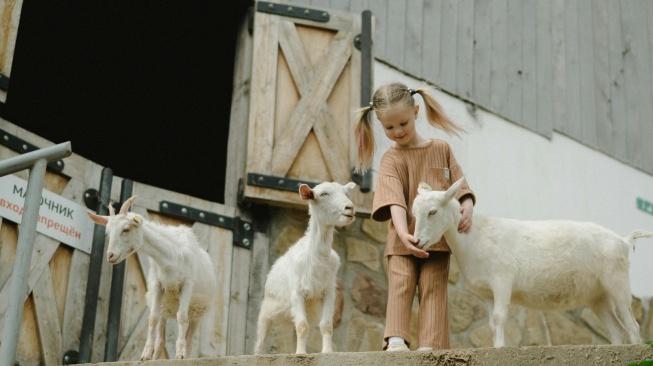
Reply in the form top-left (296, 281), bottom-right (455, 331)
top-left (287, 0), bottom-right (653, 178)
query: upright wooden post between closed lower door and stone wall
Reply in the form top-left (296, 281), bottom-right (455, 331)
top-left (243, 232), bottom-right (270, 354)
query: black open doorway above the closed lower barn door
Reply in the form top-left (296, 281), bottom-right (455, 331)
top-left (0, 0), bottom-right (251, 203)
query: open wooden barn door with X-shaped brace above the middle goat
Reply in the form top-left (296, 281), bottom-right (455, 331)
top-left (243, 2), bottom-right (371, 213)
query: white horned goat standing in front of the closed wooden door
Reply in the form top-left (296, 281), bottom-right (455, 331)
top-left (88, 196), bottom-right (217, 360)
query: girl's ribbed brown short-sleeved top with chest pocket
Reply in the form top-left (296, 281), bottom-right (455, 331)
top-left (372, 139), bottom-right (476, 256)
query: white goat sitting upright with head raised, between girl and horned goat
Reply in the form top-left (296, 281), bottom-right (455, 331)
top-left (254, 182), bottom-right (356, 354)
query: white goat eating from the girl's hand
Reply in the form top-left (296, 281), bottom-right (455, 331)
top-left (413, 178), bottom-right (653, 347)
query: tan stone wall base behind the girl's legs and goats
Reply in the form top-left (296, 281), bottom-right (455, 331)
top-left (258, 208), bottom-right (653, 353)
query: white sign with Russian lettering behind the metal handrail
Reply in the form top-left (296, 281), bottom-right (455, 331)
top-left (0, 175), bottom-right (95, 254)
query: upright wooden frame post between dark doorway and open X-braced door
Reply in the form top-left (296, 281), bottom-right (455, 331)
top-left (224, 20), bottom-right (253, 206)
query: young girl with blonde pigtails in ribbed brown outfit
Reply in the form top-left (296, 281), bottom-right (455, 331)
top-left (355, 83), bottom-right (476, 351)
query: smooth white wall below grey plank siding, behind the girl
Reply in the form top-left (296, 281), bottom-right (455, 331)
top-left (373, 62), bottom-right (653, 298)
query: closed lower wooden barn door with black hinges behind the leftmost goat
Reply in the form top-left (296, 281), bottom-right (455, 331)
top-left (0, 119), bottom-right (238, 366)
